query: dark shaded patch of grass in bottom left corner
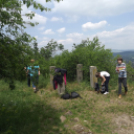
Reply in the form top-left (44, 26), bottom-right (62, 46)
top-left (0, 91), bottom-right (65, 134)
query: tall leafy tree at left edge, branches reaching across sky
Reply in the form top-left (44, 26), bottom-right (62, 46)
top-left (0, 0), bottom-right (60, 87)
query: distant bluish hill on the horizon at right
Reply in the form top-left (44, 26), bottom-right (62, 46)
top-left (113, 50), bottom-right (134, 62)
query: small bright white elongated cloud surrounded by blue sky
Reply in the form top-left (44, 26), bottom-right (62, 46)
top-left (82, 21), bottom-right (107, 30)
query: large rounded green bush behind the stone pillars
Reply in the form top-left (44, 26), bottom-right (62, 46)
top-left (53, 37), bottom-right (115, 80)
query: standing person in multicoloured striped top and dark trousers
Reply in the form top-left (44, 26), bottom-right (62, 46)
top-left (116, 58), bottom-right (128, 98)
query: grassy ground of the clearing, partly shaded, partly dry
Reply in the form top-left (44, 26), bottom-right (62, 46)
top-left (0, 80), bottom-right (134, 134)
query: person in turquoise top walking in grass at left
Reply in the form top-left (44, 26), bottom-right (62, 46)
top-left (27, 59), bottom-right (40, 93)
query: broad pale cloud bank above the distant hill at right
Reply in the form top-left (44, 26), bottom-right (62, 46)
top-left (92, 24), bottom-right (134, 50)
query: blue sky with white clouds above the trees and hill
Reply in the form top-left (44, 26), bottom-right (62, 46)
top-left (22, 0), bottom-right (134, 51)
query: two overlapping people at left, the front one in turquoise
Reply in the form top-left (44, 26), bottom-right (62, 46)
top-left (24, 59), bottom-right (40, 93)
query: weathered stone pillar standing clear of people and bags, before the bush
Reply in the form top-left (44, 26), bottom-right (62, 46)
top-left (77, 64), bottom-right (83, 83)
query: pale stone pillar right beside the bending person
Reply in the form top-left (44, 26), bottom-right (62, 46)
top-left (90, 66), bottom-right (98, 88)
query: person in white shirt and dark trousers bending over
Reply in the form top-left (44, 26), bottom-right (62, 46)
top-left (96, 71), bottom-right (110, 95)
